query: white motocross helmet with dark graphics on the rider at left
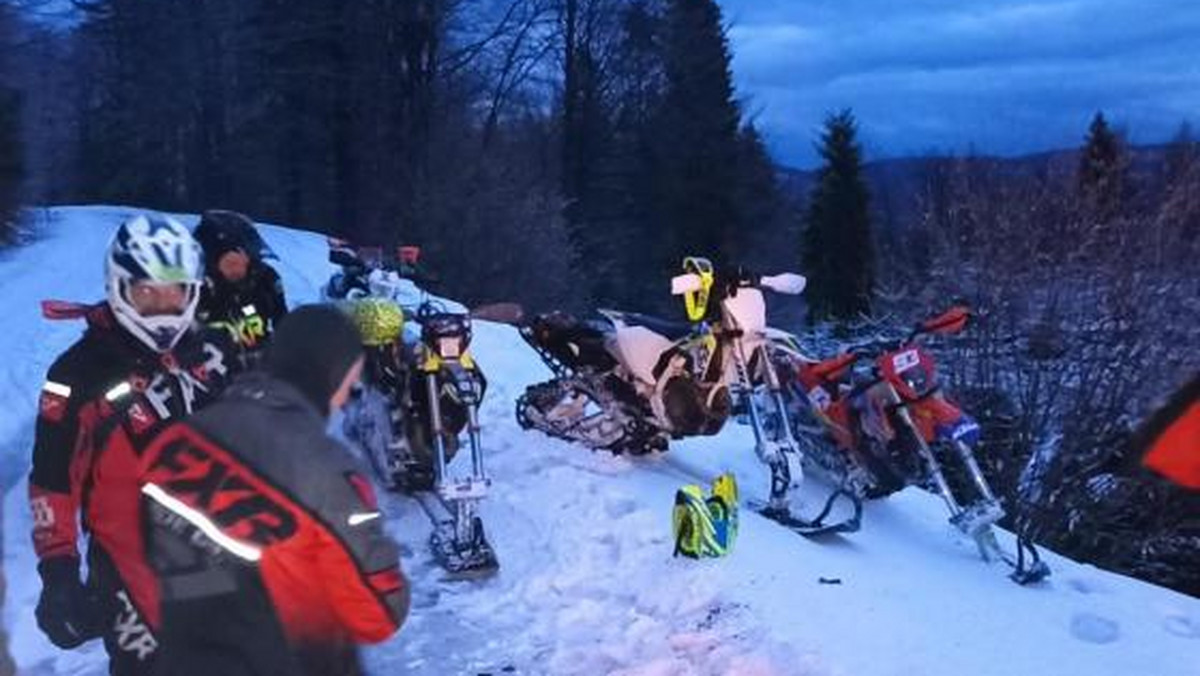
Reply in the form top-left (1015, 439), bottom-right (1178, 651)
top-left (104, 213), bottom-right (204, 352)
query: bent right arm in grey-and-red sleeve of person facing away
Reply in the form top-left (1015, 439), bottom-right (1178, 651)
top-left (316, 463), bottom-right (410, 642)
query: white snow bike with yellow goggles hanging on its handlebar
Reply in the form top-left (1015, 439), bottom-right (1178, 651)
top-left (517, 258), bottom-right (860, 534)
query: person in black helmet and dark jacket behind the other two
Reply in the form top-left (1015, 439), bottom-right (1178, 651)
top-left (194, 209), bottom-right (288, 364)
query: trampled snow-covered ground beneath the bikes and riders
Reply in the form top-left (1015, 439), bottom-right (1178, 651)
top-left (0, 208), bottom-right (1200, 676)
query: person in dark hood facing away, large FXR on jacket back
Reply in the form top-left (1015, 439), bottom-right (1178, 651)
top-left (142, 305), bottom-right (409, 676)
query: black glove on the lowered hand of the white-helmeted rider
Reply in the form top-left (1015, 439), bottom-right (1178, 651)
top-left (34, 556), bottom-right (102, 650)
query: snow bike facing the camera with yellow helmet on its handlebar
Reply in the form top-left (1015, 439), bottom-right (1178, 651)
top-left (330, 237), bottom-right (499, 576)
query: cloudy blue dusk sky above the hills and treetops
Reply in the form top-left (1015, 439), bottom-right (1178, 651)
top-left (722, 0), bottom-right (1200, 166)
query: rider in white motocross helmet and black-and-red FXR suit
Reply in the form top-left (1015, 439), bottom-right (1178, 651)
top-left (29, 213), bottom-right (233, 675)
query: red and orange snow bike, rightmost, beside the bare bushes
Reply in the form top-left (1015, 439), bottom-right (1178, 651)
top-left (781, 307), bottom-right (1050, 584)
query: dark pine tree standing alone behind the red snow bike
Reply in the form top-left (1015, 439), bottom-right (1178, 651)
top-left (804, 109), bottom-right (875, 321)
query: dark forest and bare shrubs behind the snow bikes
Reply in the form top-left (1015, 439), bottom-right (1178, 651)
top-left (0, 0), bottom-right (1200, 594)
